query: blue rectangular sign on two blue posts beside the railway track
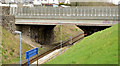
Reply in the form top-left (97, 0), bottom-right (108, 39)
top-left (26, 47), bottom-right (38, 66)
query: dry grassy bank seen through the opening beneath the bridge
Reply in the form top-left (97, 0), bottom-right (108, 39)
top-left (54, 25), bottom-right (83, 43)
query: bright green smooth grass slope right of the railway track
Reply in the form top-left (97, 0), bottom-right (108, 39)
top-left (47, 25), bottom-right (118, 64)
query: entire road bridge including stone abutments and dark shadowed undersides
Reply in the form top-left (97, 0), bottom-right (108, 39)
top-left (2, 6), bottom-right (118, 44)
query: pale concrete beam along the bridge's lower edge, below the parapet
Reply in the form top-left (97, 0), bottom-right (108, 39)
top-left (15, 19), bottom-right (118, 26)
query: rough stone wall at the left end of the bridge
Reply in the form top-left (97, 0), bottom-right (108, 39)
top-left (2, 7), bottom-right (16, 33)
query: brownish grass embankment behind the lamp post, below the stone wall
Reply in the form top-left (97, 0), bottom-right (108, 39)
top-left (2, 29), bottom-right (32, 64)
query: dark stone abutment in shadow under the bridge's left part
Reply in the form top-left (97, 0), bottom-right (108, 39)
top-left (16, 25), bottom-right (55, 45)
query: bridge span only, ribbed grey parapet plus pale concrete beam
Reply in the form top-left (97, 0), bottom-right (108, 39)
top-left (10, 6), bottom-right (118, 26)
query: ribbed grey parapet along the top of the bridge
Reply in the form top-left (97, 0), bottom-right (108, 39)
top-left (10, 6), bottom-right (118, 20)
